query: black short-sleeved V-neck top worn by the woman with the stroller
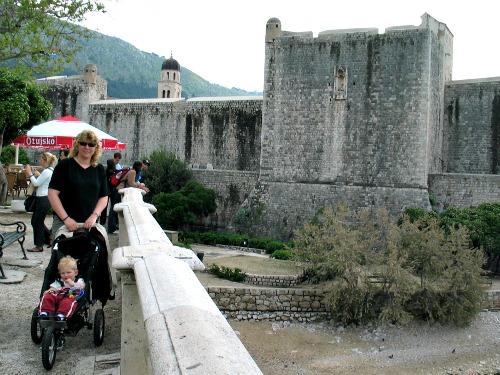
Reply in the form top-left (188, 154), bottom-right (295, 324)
top-left (49, 158), bottom-right (109, 223)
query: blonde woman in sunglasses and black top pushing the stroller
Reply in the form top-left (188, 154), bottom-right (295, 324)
top-left (48, 130), bottom-right (109, 236)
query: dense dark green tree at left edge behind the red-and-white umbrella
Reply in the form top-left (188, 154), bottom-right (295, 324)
top-left (0, 69), bottom-right (52, 201)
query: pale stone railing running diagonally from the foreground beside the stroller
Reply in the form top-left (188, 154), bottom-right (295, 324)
top-left (113, 188), bottom-right (262, 375)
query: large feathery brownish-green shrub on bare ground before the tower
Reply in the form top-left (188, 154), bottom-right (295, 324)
top-left (294, 206), bottom-right (485, 325)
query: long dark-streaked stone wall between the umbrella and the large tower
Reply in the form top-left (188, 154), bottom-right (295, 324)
top-left (90, 97), bottom-right (262, 172)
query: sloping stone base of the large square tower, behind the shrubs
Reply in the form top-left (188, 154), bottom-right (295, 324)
top-left (245, 182), bottom-right (430, 240)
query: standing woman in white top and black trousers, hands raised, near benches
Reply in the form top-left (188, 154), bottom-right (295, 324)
top-left (26, 152), bottom-right (56, 253)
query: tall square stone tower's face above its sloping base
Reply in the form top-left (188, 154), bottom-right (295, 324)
top-left (261, 17), bottom-right (450, 188)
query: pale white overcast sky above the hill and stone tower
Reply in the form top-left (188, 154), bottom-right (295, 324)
top-left (83, 0), bottom-right (500, 91)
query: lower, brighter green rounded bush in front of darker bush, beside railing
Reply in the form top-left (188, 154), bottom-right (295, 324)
top-left (152, 180), bottom-right (217, 230)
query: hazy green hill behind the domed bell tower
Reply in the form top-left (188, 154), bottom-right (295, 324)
top-left (62, 32), bottom-right (262, 99)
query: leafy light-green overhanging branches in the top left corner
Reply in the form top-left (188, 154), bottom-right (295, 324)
top-left (0, 0), bottom-right (105, 76)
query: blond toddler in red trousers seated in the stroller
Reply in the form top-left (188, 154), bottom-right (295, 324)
top-left (39, 256), bottom-right (85, 320)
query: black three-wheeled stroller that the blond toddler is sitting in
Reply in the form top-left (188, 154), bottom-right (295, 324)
top-left (31, 225), bottom-right (114, 370)
